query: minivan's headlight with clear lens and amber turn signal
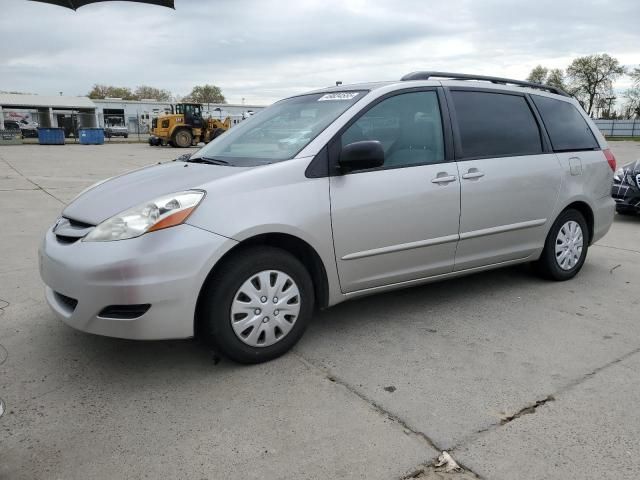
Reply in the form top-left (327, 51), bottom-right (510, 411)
top-left (84, 190), bottom-right (204, 242)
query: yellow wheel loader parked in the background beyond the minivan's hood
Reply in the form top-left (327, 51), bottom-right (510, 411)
top-left (149, 103), bottom-right (231, 148)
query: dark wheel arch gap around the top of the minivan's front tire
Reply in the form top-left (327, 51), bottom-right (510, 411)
top-left (194, 232), bottom-right (329, 337)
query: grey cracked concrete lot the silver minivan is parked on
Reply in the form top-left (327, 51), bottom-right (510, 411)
top-left (0, 142), bottom-right (640, 480)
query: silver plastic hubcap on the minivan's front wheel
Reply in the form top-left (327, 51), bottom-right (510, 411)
top-left (231, 270), bottom-right (301, 347)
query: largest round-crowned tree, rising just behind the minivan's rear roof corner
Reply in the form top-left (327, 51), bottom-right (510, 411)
top-left (567, 53), bottom-right (625, 115)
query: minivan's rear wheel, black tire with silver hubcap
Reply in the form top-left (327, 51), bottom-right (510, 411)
top-left (536, 209), bottom-right (589, 281)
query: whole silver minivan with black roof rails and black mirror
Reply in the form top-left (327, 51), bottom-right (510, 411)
top-left (39, 72), bottom-right (615, 363)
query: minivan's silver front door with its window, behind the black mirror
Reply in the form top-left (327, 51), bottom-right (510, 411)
top-left (330, 89), bottom-right (460, 293)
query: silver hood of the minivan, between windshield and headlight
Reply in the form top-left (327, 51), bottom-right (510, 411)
top-left (62, 162), bottom-right (247, 225)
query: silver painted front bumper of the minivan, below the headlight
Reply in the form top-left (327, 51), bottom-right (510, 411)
top-left (39, 224), bottom-right (236, 340)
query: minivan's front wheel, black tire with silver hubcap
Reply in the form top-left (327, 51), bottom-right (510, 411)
top-left (199, 246), bottom-right (314, 363)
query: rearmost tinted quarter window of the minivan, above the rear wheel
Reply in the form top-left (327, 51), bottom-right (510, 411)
top-left (531, 95), bottom-right (600, 152)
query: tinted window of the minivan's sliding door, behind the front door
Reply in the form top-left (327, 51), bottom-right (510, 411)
top-left (451, 90), bottom-right (542, 158)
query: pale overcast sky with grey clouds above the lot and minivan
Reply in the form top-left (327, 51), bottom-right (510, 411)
top-left (0, 0), bottom-right (640, 104)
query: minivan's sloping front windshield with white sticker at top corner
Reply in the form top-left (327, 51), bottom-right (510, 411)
top-left (193, 91), bottom-right (366, 166)
